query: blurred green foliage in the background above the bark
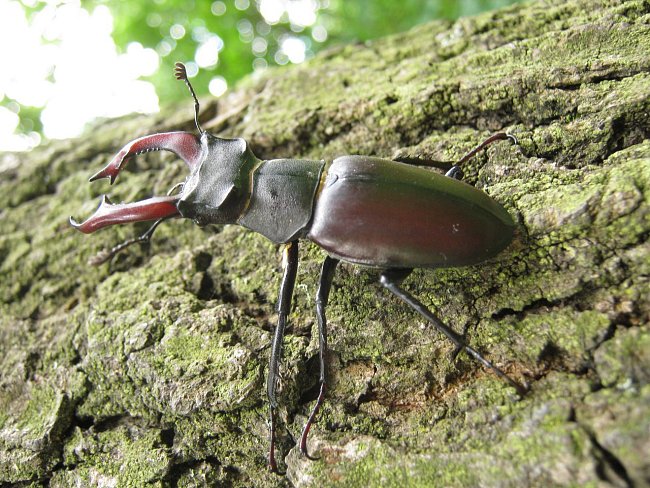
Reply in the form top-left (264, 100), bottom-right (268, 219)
top-left (0, 0), bottom-right (518, 144)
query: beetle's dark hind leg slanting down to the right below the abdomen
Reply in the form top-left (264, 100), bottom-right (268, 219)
top-left (380, 269), bottom-right (527, 396)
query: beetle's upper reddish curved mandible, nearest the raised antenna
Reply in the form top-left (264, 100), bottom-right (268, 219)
top-left (90, 132), bottom-right (202, 184)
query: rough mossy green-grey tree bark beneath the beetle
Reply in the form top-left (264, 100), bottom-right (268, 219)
top-left (0, 0), bottom-right (650, 487)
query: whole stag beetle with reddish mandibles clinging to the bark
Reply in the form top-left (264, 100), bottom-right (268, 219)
top-left (70, 63), bottom-right (526, 472)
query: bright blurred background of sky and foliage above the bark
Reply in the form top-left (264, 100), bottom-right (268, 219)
top-left (0, 0), bottom-right (517, 151)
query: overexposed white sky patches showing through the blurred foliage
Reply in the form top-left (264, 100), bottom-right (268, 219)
top-left (0, 0), bottom-right (314, 151)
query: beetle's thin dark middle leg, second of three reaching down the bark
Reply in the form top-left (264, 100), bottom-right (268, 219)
top-left (300, 256), bottom-right (339, 460)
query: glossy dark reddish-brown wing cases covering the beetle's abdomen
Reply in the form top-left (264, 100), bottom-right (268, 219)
top-left (307, 156), bottom-right (514, 268)
